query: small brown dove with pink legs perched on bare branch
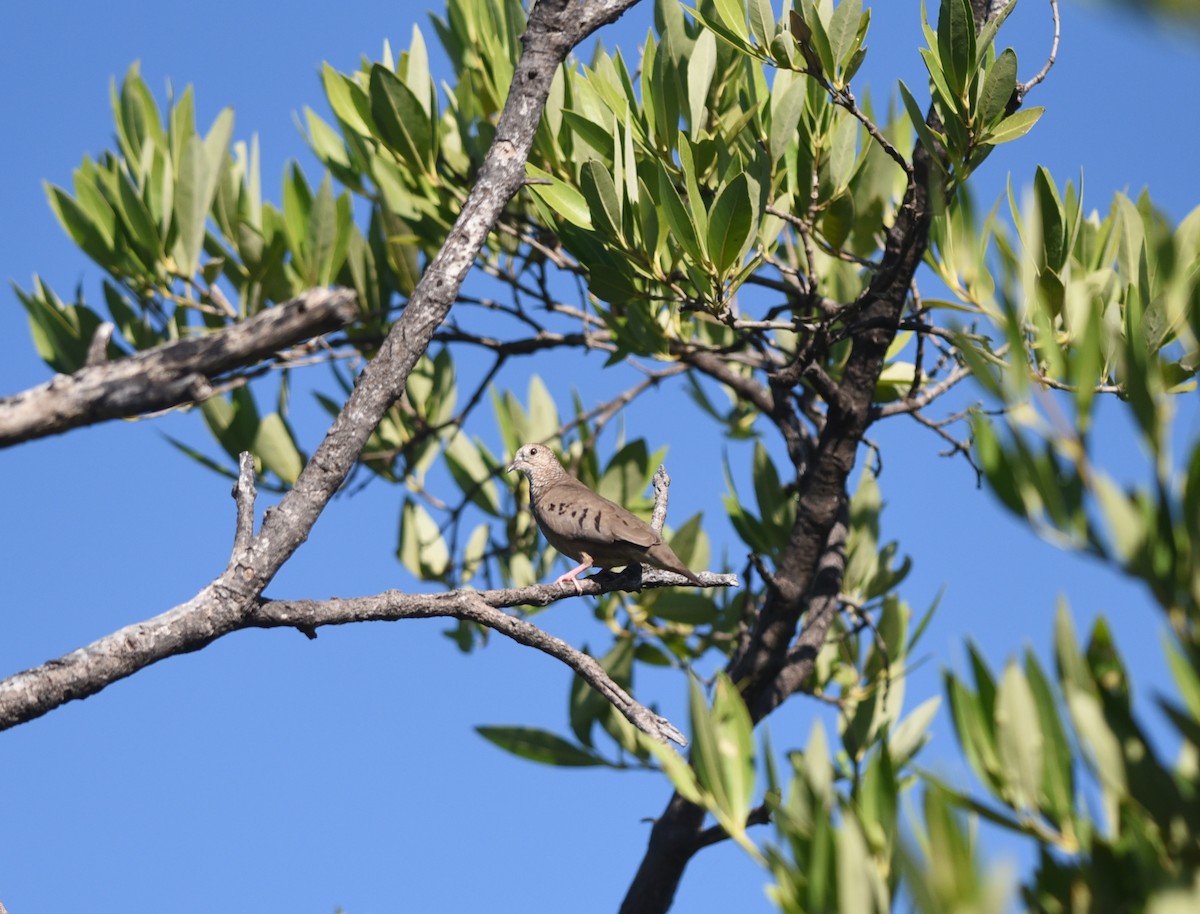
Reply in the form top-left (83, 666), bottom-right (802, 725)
top-left (505, 444), bottom-right (703, 594)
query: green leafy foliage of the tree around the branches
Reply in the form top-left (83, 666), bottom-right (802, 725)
top-left (18, 0), bottom-right (1200, 912)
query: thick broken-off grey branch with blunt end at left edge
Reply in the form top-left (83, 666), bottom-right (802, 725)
top-left (0, 289), bottom-right (356, 447)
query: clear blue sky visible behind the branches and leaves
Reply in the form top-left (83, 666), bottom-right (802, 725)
top-left (0, 0), bottom-right (1200, 914)
